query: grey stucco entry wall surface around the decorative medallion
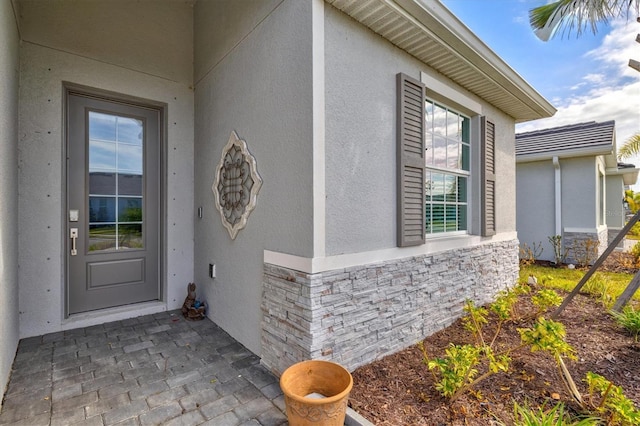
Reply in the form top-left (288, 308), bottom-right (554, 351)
top-left (194, 1), bottom-right (313, 353)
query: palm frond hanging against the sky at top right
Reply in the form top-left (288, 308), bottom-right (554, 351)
top-left (529, 0), bottom-right (640, 41)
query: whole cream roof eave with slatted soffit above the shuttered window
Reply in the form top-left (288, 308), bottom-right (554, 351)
top-left (325, 0), bottom-right (556, 122)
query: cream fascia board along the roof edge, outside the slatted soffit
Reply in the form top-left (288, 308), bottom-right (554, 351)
top-left (390, 0), bottom-right (557, 117)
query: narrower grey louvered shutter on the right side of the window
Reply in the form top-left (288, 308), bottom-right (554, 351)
top-left (480, 117), bottom-right (496, 237)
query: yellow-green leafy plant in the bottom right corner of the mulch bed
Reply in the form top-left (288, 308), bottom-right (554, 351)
top-left (584, 371), bottom-right (640, 425)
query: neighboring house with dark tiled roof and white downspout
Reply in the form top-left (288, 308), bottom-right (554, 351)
top-left (516, 121), bottom-right (638, 262)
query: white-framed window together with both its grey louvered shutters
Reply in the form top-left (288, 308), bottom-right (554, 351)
top-left (396, 73), bottom-right (496, 247)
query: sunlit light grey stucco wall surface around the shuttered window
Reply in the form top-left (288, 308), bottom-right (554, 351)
top-left (325, 6), bottom-right (515, 255)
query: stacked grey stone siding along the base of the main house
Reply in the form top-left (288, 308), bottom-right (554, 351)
top-left (261, 240), bottom-right (518, 374)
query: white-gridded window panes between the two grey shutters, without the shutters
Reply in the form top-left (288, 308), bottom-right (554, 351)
top-left (425, 99), bottom-right (470, 234)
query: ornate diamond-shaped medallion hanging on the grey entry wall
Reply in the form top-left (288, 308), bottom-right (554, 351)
top-left (211, 131), bottom-right (262, 240)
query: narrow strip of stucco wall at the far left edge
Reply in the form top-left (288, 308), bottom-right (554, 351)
top-left (0, 1), bottom-right (19, 401)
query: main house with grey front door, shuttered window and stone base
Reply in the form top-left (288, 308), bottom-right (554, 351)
top-left (0, 0), bottom-right (555, 402)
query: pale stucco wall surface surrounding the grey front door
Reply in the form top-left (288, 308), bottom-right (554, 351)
top-left (19, 42), bottom-right (193, 337)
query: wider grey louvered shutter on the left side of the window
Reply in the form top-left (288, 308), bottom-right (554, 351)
top-left (396, 73), bottom-right (425, 247)
